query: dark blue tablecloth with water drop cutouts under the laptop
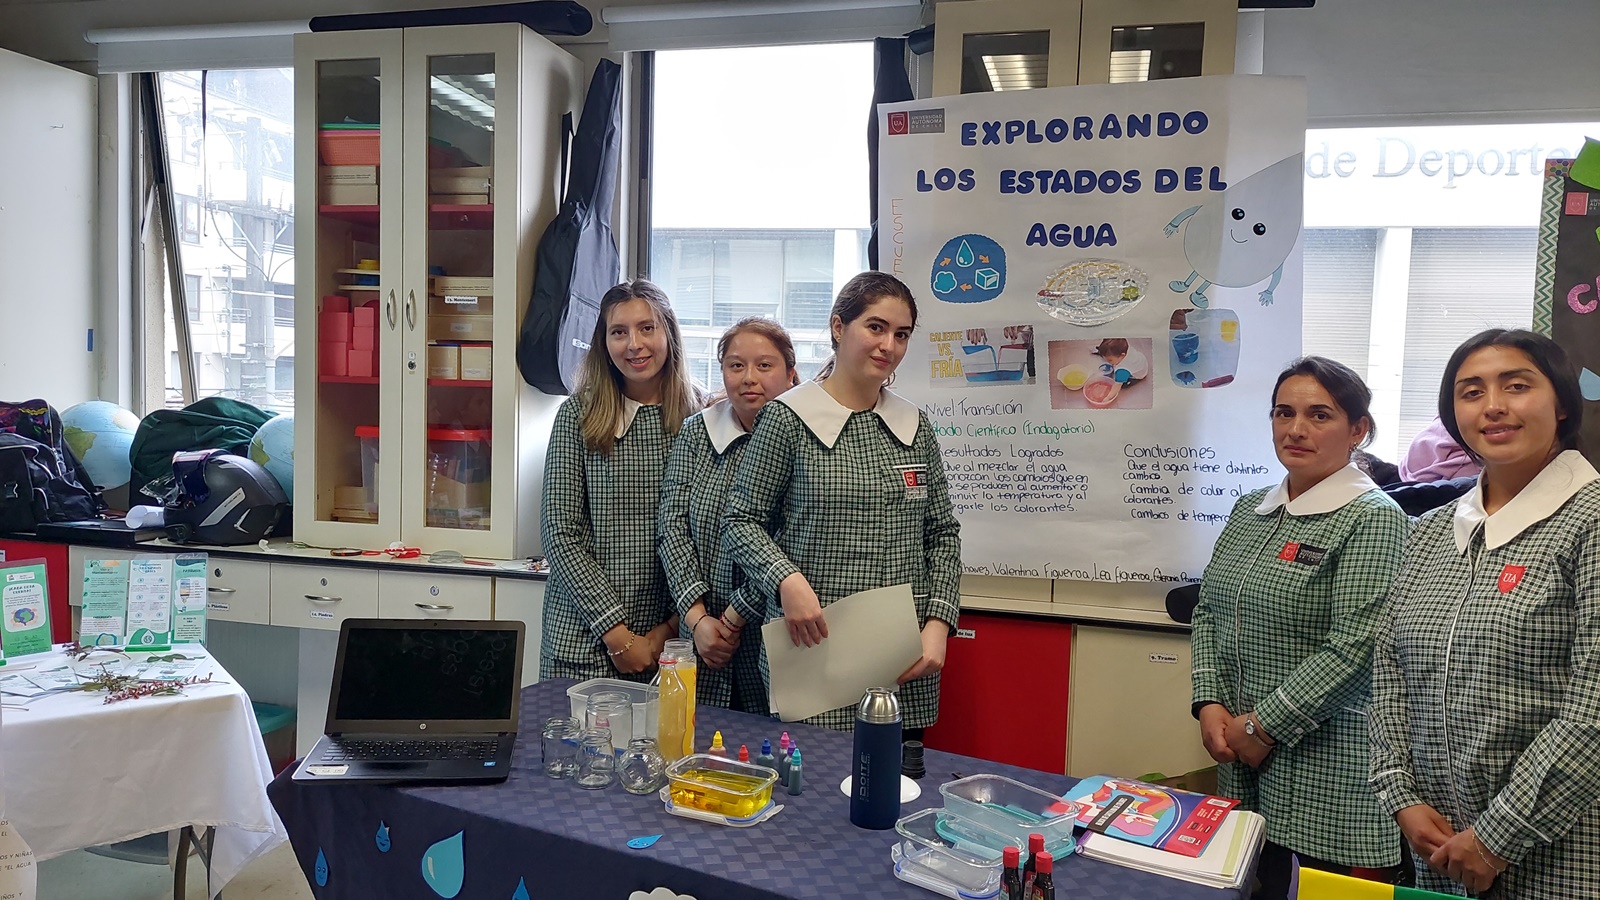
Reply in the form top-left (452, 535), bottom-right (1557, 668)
top-left (267, 681), bottom-right (1238, 900)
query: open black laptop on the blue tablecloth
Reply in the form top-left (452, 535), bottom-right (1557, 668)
top-left (294, 618), bottom-right (525, 783)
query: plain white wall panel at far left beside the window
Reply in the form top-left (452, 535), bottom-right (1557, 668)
top-left (0, 50), bottom-right (99, 403)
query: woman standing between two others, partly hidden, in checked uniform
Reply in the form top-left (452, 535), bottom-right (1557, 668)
top-left (656, 317), bottom-right (800, 716)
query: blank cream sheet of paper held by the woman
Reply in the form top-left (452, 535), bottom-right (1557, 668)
top-left (762, 585), bottom-right (922, 722)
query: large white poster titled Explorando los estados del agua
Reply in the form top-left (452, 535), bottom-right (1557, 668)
top-left (878, 75), bottom-right (1306, 583)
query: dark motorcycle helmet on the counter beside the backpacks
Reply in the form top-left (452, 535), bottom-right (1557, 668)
top-left (166, 450), bottom-right (290, 544)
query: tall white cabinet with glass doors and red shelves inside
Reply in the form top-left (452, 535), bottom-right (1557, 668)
top-left (294, 24), bottom-right (582, 559)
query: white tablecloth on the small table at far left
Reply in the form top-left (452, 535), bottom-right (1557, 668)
top-left (0, 647), bottom-right (288, 895)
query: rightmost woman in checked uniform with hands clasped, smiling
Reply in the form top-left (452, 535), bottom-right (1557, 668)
top-left (1371, 328), bottom-right (1600, 900)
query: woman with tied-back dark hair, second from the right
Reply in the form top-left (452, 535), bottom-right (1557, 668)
top-left (1190, 357), bottom-right (1408, 898)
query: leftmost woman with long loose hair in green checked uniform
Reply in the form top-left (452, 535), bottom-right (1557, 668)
top-left (539, 280), bottom-right (699, 681)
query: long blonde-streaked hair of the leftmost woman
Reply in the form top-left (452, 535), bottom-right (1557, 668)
top-left (576, 279), bottom-right (701, 456)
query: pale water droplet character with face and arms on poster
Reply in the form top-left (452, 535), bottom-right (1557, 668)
top-left (1165, 154), bottom-right (1304, 309)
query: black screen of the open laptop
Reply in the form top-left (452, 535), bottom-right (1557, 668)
top-left (330, 623), bottom-right (522, 722)
